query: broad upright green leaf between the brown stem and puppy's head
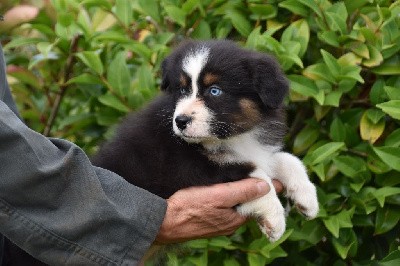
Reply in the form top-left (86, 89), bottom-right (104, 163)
top-left (107, 52), bottom-right (131, 97)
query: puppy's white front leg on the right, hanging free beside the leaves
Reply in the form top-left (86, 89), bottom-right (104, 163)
top-left (274, 152), bottom-right (319, 219)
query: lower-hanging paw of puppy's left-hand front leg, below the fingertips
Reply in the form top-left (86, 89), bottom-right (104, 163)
top-left (258, 211), bottom-right (286, 242)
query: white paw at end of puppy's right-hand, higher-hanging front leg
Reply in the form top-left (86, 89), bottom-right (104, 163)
top-left (291, 184), bottom-right (319, 219)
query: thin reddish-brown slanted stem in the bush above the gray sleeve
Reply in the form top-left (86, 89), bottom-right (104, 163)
top-left (43, 35), bottom-right (80, 137)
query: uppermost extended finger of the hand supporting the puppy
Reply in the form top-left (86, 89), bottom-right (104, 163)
top-left (214, 178), bottom-right (271, 208)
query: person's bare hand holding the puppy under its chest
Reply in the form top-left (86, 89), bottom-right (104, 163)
top-left (155, 178), bottom-right (283, 244)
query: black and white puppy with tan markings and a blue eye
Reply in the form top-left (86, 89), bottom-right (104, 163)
top-left (93, 41), bottom-right (318, 241)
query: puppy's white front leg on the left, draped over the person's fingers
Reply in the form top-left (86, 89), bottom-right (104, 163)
top-left (237, 169), bottom-right (286, 241)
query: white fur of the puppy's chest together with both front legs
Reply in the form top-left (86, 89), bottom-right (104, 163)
top-left (203, 131), bottom-right (318, 241)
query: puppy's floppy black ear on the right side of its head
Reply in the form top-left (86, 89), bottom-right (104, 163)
top-left (249, 53), bottom-right (289, 109)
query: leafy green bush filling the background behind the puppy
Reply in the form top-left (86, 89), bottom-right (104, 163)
top-left (0, 0), bottom-right (400, 265)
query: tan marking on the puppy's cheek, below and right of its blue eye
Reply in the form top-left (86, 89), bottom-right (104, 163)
top-left (234, 99), bottom-right (261, 129)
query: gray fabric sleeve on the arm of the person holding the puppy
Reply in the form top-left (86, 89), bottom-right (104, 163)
top-left (0, 47), bottom-right (166, 265)
